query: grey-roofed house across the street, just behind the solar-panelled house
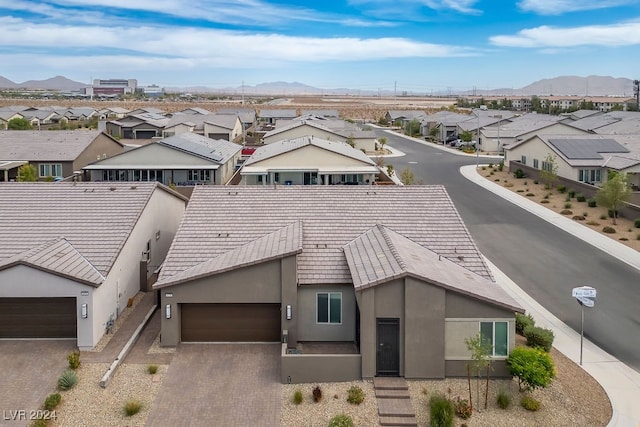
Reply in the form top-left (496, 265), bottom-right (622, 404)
top-left (480, 114), bottom-right (586, 153)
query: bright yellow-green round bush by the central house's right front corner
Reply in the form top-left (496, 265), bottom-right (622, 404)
top-left (507, 347), bottom-right (556, 391)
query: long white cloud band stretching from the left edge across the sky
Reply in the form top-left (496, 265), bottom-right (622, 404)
top-left (0, 17), bottom-right (475, 63)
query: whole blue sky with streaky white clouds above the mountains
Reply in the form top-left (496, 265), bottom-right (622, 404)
top-left (0, 0), bottom-right (640, 94)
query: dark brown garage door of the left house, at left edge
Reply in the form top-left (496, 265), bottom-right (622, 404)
top-left (0, 298), bottom-right (77, 338)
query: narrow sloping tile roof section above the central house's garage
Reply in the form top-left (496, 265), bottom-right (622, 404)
top-left (155, 221), bottom-right (302, 288)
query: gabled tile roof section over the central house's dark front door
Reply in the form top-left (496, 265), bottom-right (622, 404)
top-left (344, 224), bottom-right (522, 311)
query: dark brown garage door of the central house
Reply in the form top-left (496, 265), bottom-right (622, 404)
top-left (181, 304), bottom-right (280, 342)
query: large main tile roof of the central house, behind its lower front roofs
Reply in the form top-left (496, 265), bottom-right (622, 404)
top-left (160, 186), bottom-right (491, 284)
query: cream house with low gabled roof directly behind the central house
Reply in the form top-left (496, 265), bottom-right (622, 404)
top-left (240, 136), bottom-right (380, 185)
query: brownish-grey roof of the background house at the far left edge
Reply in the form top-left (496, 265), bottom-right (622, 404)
top-left (0, 130), bottom-right (115, 161)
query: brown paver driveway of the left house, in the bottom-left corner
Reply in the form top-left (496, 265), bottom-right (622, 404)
top-left (0, 340), bottom-right (76, 426)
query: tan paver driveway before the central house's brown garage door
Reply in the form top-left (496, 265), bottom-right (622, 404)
top-left (147, 344), bottom-right (281, 427)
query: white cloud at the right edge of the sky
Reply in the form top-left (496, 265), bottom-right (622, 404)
top-left (490, 22), bottom-right (640, 48)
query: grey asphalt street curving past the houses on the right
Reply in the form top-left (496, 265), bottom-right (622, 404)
top-left (376, 129), bottom-right (640, 371)
